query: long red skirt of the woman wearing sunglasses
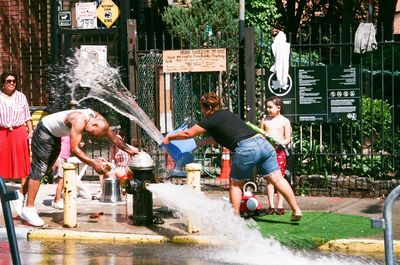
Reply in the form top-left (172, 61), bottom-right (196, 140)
top-left (0, 125), bottom-right (31, 179)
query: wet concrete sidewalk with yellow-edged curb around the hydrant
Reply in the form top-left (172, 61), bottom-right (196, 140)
top-left (0, 182), bottom-right (400, 253)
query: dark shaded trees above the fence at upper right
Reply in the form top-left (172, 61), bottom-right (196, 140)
top-left (275, 0), bottom-right (397, 41)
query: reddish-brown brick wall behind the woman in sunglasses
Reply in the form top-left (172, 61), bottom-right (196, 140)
top-left (0, 0), bottom-right (50, 106)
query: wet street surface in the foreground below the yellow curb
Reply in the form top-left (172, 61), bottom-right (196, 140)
top-left (0, 239), bottom-right (390, 265)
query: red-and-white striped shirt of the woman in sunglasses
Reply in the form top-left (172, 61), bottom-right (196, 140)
top-left (0, 90), bottom-right (32, 128)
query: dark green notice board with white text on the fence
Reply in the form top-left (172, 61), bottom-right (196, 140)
top-left (266, 65), bottom-right (361, 123)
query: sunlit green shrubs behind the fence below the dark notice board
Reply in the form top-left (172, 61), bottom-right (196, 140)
top-left (293, 97), bottom-right (400, 179)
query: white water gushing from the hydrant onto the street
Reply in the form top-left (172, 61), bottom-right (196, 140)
top-left (147, 183), bottom-right (382, 265)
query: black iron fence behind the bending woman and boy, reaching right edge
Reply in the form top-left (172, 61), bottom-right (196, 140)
top-left (135, 25), bottom-right (400, 197)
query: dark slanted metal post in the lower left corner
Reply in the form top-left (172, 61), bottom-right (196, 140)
top-left (0, 177), bottom-right (21, 265)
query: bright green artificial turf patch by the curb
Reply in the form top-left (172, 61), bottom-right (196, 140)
top-left (253, 211), bottom-right (383, 249)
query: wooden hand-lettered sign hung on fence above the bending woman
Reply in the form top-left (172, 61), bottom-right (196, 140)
top-left (163, 49), bottom-right (226, 73)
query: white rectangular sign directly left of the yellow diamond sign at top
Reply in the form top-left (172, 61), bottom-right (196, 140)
top-left (75, 2), bottom-right (97, 29)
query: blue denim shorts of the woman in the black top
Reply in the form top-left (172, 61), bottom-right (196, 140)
top-left (231, 135), bottom-right (279, 180)
